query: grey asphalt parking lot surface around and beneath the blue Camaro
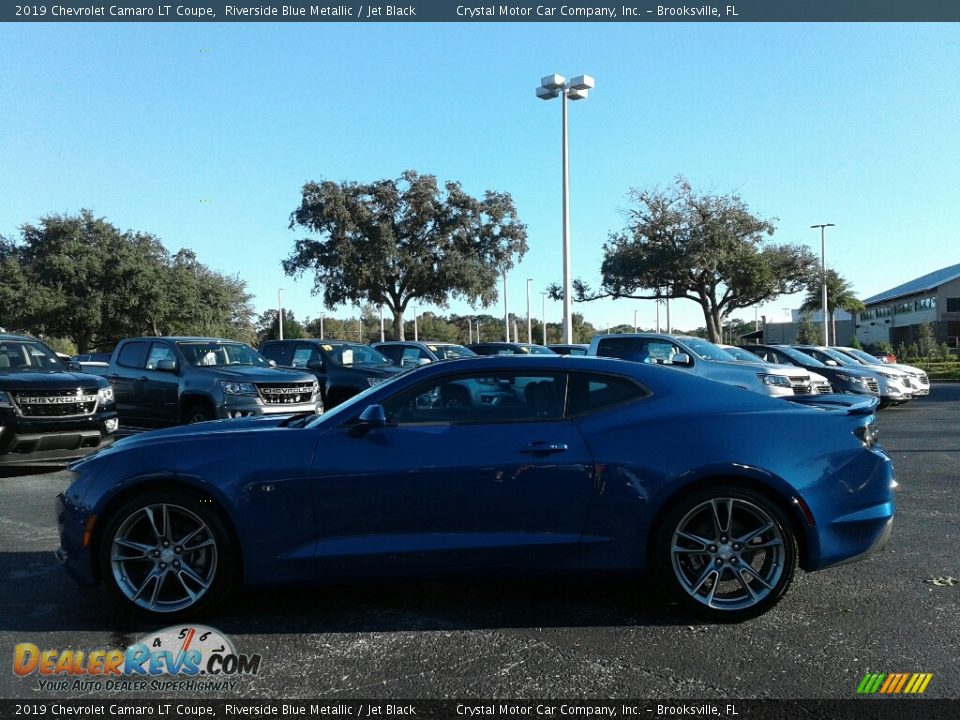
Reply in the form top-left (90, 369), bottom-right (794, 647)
top-left (0, 384), bottom-right (960, 699)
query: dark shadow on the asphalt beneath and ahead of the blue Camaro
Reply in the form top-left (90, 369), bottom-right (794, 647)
top-left (0, 552), bottom-right (700, 636)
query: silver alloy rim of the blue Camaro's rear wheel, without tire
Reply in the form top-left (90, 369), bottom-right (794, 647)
top-left (670, 497), bottom-right (786, 610)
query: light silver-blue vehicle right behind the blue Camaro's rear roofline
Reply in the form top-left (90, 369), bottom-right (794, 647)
top-left (587, 333), bottom-right (810, 397)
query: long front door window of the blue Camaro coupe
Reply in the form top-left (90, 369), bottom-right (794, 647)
top-left (383, 371), bottom-right (566, 425)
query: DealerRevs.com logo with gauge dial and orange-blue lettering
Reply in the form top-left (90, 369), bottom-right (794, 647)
top-left (13, 625), bottom-right (262, 692)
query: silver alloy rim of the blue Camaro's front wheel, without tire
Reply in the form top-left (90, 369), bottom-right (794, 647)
top-left (110, 503), bottom-right (217, 613)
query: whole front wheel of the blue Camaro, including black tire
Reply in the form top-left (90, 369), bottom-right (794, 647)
top-left (98, 488), bottom-right (239, 621)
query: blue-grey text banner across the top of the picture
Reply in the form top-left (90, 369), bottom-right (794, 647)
top-left (0, 0), bottom-right (960, 23)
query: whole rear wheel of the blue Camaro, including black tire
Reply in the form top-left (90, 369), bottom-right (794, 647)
top-left (655, 485), bottom-right (797, 622)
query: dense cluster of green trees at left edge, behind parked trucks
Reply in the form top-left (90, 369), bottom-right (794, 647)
top-left (0, 210), bottom-right (253, 353)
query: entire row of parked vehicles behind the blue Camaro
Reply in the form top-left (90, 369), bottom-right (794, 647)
top-left (0, 326), bottom-right (930, 463)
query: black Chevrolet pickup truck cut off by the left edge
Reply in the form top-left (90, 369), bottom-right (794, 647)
top-left (0, 333), bottom-right (118, 467)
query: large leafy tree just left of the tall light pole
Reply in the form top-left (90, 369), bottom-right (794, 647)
top-left (283, 170), bottom-right (527, 339)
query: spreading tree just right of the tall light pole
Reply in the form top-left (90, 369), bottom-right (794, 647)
top-left (564, 177), bottom-right (817, 342)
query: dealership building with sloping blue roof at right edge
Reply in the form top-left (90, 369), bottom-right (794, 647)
top-left (856, 264), bottom-right (960, 347)
